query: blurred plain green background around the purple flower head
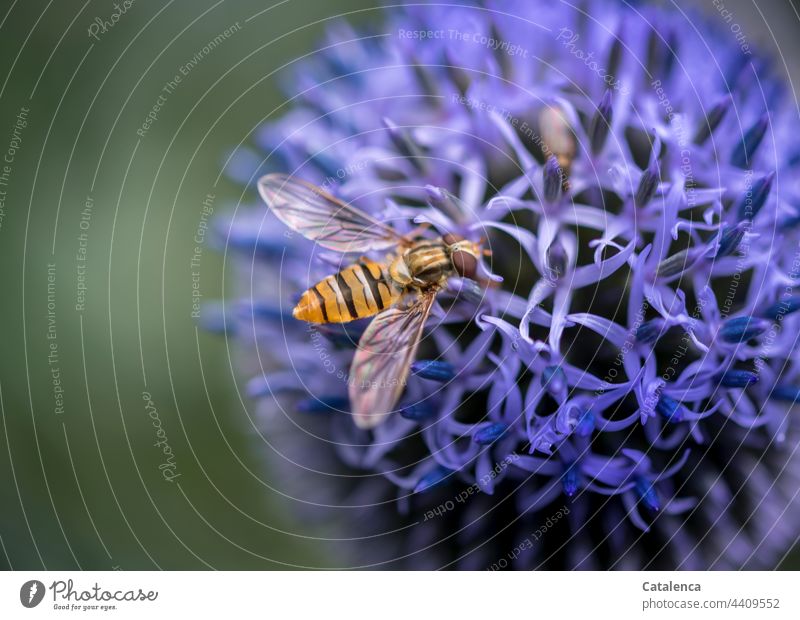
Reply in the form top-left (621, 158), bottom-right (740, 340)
top-left (0, 0), bottom-right (796, 570)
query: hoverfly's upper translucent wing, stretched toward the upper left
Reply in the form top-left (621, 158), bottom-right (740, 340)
top-left (258, 174), bottom-right (406, 253)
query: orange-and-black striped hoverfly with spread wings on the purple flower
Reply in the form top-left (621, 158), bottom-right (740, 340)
top-left (258, 174), bottom-right (488, 429)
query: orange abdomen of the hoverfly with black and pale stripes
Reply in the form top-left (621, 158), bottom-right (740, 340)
top-left (293, 261), bottom-right (403, 323)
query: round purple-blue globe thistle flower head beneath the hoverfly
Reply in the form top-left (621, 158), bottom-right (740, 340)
top-left (218, 0), bottom-right (800, 569)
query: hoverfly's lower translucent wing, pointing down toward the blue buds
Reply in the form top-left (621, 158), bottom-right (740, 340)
top-left (348, 290), bottom-right (436, 428)
